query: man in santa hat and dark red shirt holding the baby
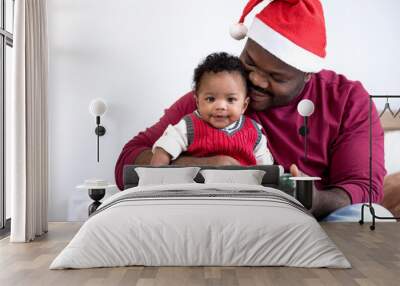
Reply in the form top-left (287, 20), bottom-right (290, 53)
top-left (115, 0), bottom-right (386, 218)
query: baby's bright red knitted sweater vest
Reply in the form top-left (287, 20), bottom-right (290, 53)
top-left (185, 113), bottom-right (261, 166)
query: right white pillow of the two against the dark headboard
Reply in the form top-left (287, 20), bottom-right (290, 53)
top-left (200, 169), bottom-right (265, 185)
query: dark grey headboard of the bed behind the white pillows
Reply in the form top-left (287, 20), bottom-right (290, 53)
top-left (123, 165), bottom-right (283, 190)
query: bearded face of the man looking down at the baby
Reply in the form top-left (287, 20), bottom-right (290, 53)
top-left (240, 39), bottom-right (310, 111)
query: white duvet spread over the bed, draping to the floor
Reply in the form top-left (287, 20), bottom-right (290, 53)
top-left (50, 184), bottom-right (351, 269)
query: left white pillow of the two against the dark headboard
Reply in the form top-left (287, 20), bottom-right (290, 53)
top-left (135, 167), bottom-right (200, 186)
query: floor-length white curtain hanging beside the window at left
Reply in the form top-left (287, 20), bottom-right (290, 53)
top-left (9, 0), bottom-right (48, 242)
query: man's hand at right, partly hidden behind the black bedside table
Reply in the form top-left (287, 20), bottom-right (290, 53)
top-left (290, 164), bottom-right (351, 219)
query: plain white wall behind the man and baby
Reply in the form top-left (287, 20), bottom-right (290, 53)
top-left (48, 0), bottom-right (400, 221)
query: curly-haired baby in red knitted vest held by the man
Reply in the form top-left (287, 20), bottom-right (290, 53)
top-left (150, 53), bottom-right (273, 166)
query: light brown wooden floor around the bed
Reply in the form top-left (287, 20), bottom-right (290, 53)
top-left (0, 223), bottom-right (400, 286)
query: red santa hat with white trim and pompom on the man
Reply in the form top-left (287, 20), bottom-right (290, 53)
top-left (230, 0), bottom-right (326, 72)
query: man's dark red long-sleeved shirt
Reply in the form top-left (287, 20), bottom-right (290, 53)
top-left (115, 70), bottom-right (386, 203)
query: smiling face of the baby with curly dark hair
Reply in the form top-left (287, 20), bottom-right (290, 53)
top-left (196, 72), bottom-right (249, 129)
